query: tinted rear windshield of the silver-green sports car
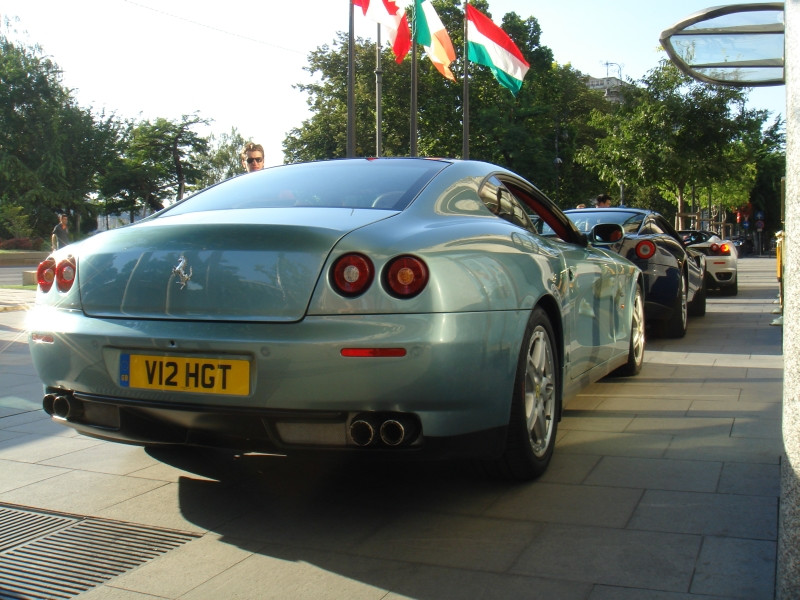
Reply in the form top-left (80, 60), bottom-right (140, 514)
top-left (160, 159), bottom-right (449, 216)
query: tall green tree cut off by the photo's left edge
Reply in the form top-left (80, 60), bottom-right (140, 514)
top-left (0, 24), bottom-right (126, 235)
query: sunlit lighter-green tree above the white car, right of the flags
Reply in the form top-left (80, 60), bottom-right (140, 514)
top-left (577, 60), bottom-right (766, 226)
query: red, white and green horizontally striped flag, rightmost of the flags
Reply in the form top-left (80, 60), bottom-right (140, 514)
top-left (467, 4), bottom-right (530, 96)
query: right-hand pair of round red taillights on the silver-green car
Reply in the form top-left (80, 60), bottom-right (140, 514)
top-left (330, 253), bottom-right (428, 298)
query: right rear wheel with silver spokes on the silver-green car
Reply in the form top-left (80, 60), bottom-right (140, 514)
top-left (487, 307), bottom-right (561, 481)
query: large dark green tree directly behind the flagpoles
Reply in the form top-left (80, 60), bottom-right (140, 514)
top-left (284, 0), bottom-right (605, 203)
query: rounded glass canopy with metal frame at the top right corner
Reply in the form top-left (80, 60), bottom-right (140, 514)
top-left (660, 2), bottom-right (785, 87)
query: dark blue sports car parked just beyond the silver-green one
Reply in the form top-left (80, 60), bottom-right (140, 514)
top-left (566, 207), bottom-right (706, 338)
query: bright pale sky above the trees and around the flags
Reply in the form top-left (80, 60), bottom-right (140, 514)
top-left (0, 0), bottom-right (786, 164)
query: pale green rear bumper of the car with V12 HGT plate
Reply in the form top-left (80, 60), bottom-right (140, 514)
top-left (29, 308), bottom-right (528, 454)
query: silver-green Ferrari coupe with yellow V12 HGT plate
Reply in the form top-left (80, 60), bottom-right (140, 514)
top-left (28, 158), bottom-right (645, 479)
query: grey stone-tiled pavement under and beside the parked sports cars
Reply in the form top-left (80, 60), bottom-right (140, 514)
top-left (0, 258), bottom-right (783, 600)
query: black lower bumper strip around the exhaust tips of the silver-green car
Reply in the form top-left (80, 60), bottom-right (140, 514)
top-left (44, 388), bottom-right (506, 459)
